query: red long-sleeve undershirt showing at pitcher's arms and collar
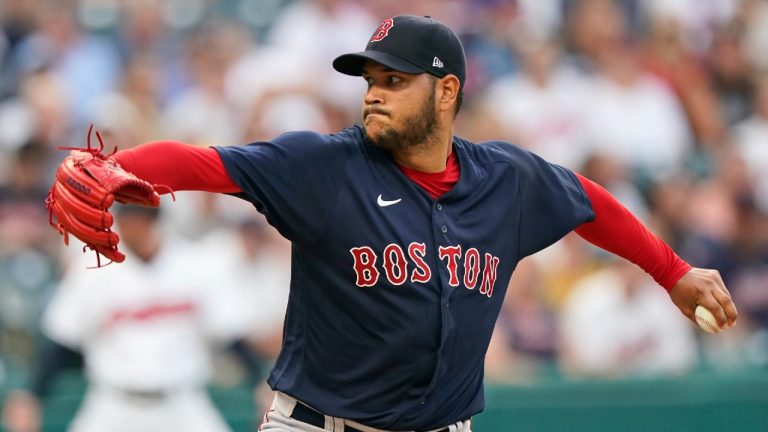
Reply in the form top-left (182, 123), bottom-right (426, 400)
top-left (115, 141), bottom-right (691, 290)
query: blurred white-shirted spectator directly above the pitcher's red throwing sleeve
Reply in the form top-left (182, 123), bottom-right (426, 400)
top-left (570, 0), bottom-right (691, 184)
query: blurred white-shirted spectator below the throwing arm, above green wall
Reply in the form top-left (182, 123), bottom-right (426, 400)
top-left (560, 261), bottom-right (697, 377)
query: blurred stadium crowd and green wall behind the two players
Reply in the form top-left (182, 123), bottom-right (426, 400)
top-left (0, 0), bottom-right (768, 432)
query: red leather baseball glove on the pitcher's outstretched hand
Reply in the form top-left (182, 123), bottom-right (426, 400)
top-left (45, 125), bottom-right (160, 267)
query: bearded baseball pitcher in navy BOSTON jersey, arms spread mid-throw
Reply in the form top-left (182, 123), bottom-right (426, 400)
top-left (43, 15), bottom-right (737, 432)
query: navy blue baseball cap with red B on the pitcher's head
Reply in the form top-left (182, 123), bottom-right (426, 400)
top-left (333, 15), bottom-right (466, 87)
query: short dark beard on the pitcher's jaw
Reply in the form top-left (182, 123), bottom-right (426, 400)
top-left (363, 87), bottom-right (437, 153)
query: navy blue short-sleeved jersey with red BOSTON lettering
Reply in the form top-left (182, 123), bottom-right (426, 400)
top-left (217, 126), bottom-right (594, 430)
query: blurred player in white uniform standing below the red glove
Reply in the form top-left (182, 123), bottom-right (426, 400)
top-left (43, 206), bottom-right (253, 432)
